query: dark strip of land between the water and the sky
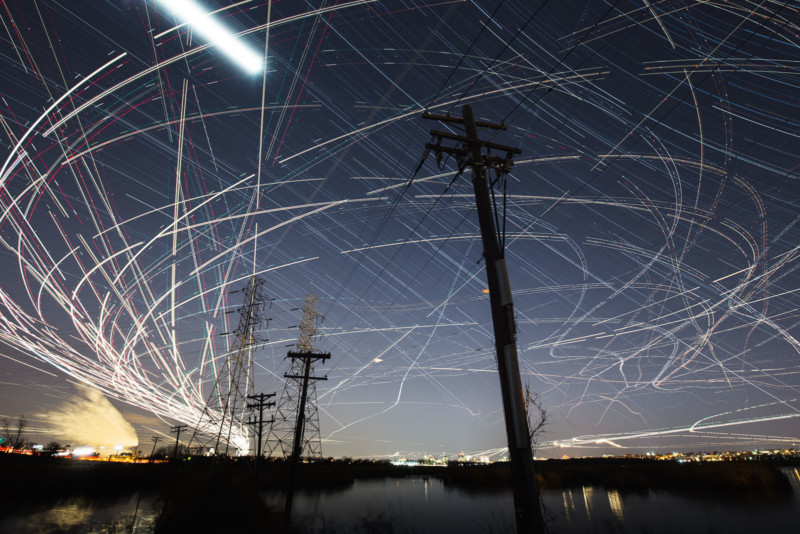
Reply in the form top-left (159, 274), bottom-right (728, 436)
top-left (0, 454), bottom-right (791, 501)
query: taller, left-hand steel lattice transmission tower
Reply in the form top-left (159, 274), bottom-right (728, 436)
top-left (192, 276), bottom-right (272, 455)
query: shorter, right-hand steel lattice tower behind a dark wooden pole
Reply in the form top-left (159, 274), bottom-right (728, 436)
top-left (267, 294), bottom-right (331, 461)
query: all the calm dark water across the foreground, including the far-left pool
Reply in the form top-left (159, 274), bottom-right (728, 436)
top-left (0, 468), bottom-right (800, 534)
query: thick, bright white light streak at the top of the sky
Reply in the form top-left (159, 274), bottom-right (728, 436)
top-left (156, 0), bottom-right (263, 74)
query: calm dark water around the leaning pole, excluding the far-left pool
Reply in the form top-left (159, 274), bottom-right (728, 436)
top-left (276, 468), bottom-right (800, 534)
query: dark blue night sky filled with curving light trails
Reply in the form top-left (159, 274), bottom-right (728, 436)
top-left (0, 0), bottom-right (800, 457)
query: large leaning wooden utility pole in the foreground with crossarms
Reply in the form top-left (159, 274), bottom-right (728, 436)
top-left (422, 105), bottom-right (544, 534)
